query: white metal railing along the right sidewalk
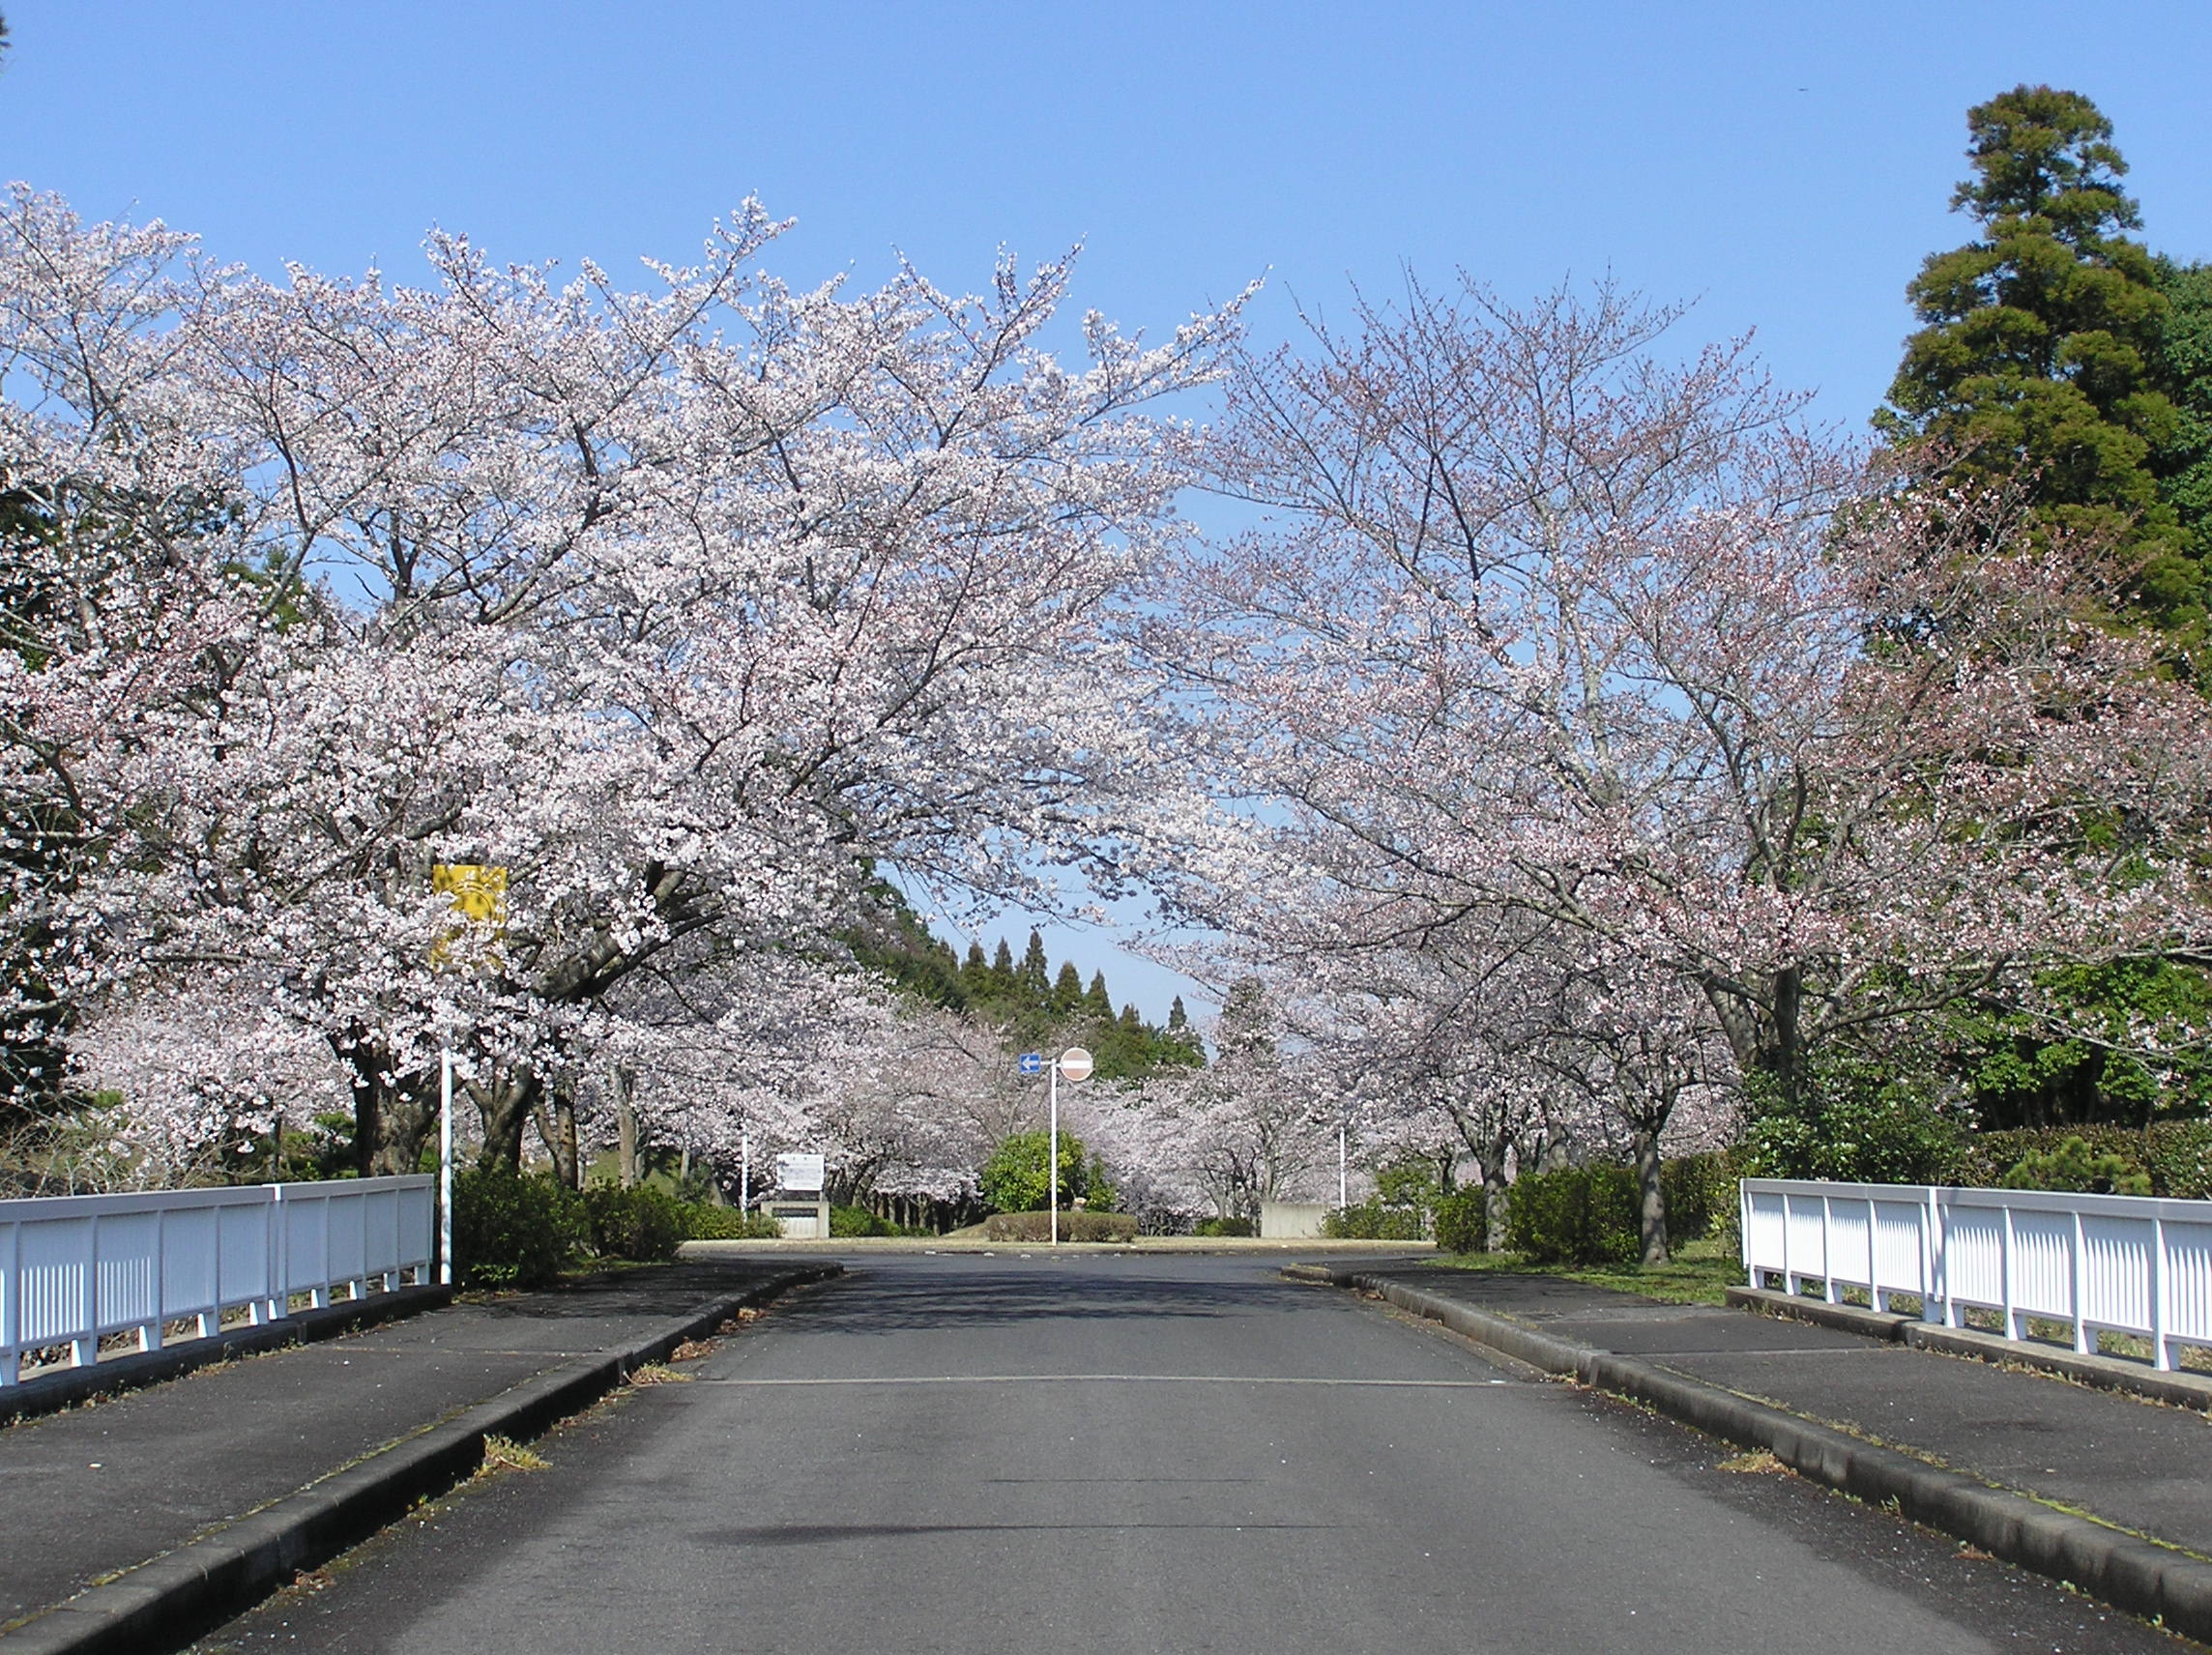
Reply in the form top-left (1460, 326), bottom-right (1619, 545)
top-left (1738, 1177), bottom-right (2212, 1370)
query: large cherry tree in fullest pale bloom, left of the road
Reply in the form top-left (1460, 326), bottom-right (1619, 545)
top-left (0, 190), bottom-right (1235, 1171)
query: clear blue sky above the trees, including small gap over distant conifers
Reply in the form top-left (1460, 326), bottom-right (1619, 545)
top-left (0, 0), bottom-right (2212, 1018)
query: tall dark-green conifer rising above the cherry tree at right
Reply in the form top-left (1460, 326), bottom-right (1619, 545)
top-left (1876, 86), bottom-right (2205, 644)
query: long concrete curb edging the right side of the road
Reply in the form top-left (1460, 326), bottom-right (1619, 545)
top-left (1305, 1265), bottom-right (2212, 1641)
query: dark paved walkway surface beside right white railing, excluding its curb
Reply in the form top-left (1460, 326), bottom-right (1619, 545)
top-left (1365, 1265), bottom-right (2212, 1557)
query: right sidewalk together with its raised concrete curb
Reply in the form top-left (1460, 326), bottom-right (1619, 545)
top-left (1298, 1262), bottom-right (2212, 1638)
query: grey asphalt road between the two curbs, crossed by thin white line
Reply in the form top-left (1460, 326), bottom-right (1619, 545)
top-left (201, 1250), bottom-right (2188, 1655)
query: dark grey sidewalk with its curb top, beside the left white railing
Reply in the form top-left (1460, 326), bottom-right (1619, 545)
top-left (0, 1259), bottom-right (836, 1655)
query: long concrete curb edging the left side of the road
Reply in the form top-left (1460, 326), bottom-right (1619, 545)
top-left (0, 1263), bottom-right (843, 1655)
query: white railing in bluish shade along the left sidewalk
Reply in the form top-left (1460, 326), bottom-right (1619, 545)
top-left (0, 1175), bottom-right (436, 1385)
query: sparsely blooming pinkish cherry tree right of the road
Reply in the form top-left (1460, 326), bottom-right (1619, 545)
top-left (1146, 274), bottom-right (2212, 1212)
